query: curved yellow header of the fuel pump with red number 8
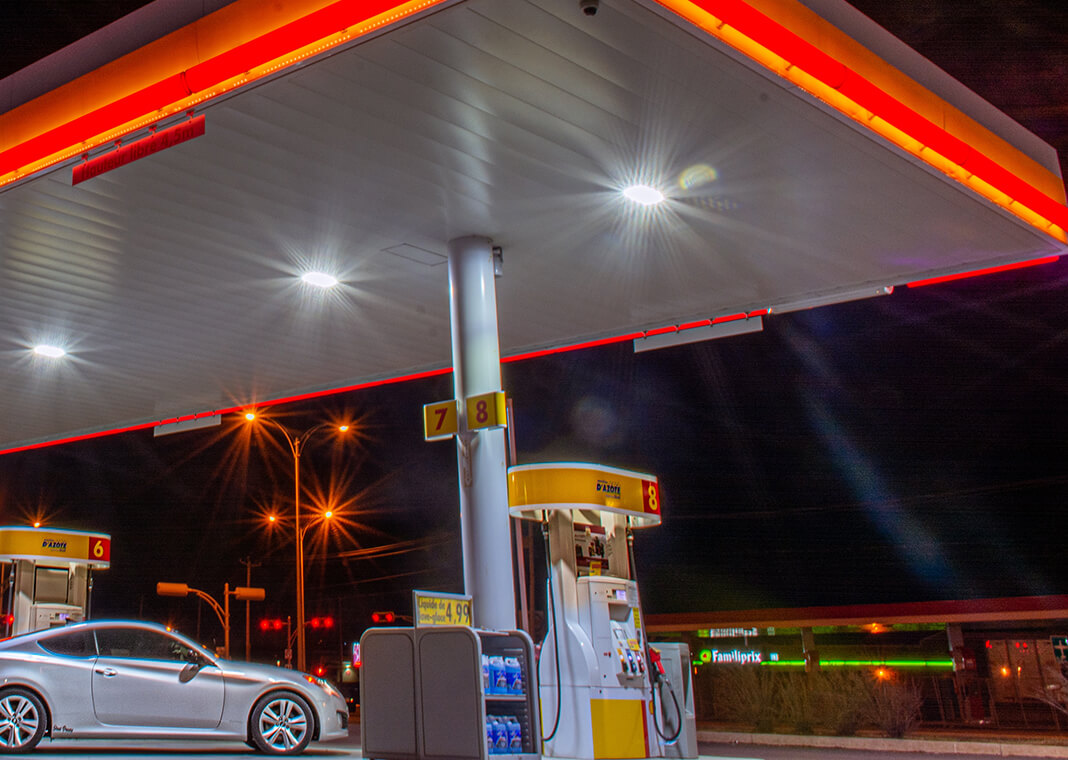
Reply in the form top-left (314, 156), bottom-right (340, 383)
top-left (508, 462), bottom-right (660, 525)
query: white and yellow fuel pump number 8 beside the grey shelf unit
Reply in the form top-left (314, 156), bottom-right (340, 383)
top-left (508, 463), bottom-right (683, 760)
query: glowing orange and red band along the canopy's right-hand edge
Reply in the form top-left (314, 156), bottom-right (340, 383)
top-left (657, 0), bottom-right (1068, 242)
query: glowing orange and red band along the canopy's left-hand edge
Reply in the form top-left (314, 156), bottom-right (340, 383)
top-left (0, 0), bottom-right (447, 187)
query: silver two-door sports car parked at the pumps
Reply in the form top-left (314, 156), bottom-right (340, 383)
top-left (0, 621), bottom-right (348, 755)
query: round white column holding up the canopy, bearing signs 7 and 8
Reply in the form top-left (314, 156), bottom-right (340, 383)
top-left (449, 236), bottom-right (516, 630)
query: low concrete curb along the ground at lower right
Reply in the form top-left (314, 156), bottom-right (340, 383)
top-left (697, 730), bottom-right (1068, 758)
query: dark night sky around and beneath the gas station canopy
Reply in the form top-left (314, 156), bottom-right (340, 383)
top-left (0, 0), bottom-right (1068, 646)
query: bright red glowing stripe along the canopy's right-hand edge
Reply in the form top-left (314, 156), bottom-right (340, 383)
top-left (674, 0), bottom-right (1068, 228)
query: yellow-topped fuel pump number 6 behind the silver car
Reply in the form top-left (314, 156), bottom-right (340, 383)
top-left (0, 526), bottom-right (111, 635)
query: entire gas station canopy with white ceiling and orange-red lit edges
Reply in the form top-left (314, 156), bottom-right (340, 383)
top-left (0, 0), bottom-right (1068, 452)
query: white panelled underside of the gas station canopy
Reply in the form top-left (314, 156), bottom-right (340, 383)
top-left (0, 0), bottom-right (1065, 449)
